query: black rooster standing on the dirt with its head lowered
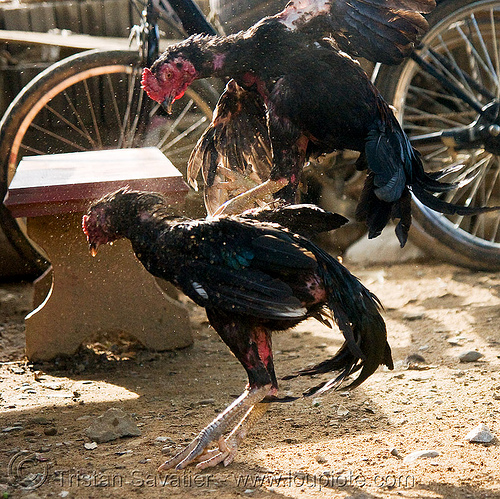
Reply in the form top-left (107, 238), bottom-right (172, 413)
top-left (83, 190), bottom-right (393, 469)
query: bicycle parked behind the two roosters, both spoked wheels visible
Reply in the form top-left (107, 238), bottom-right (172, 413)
top-left (0, 0), bottom-right (500, 270)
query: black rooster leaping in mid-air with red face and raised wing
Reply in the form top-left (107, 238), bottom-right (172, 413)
top-left (142, 0), bottom-right (496, 246)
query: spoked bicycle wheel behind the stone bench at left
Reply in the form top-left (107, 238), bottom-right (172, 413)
top-left (0, 50), bottom-right (218, 274)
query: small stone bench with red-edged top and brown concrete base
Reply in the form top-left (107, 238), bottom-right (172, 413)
top-left (5, 148), bottom-right (192, 360)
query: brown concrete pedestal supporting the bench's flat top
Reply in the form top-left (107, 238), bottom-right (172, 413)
top-left (26, 213), bottom-right (193, 360)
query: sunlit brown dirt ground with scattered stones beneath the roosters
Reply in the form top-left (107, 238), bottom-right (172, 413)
top-left (0, 264), bottom-right (500, 499)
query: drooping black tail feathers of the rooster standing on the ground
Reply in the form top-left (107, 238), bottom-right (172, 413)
top-left (288, 243), bottom-right (393, 395)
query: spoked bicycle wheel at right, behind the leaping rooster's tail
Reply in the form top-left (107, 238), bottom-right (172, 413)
top-left (376, 0), bottom-right (500, 270)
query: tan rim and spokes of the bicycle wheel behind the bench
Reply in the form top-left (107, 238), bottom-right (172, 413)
top-left (3, 53), bottom-right (215, 182)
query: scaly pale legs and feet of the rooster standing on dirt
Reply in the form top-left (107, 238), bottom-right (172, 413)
top-left (158, 385), bottom-right (271, 471)
